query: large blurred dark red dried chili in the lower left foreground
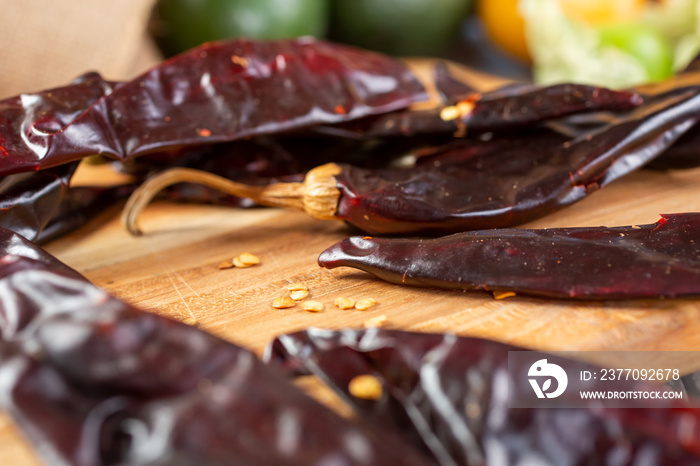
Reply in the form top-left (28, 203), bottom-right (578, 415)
top-left (0, 229), bottom-right (433, 466)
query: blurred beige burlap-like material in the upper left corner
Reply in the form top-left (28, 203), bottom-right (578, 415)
top-left (0, 0), bottom-right (160, 98)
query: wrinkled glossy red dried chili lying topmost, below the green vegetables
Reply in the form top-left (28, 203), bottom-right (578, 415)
top-left (0, 38), bottom-right (426, 174)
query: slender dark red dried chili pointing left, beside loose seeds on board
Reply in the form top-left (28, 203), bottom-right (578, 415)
top-left (318, 213), bottom-right (700, 299)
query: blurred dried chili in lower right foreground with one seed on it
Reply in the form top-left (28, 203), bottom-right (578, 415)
top-left (266, 329), bottom-right (700, 466)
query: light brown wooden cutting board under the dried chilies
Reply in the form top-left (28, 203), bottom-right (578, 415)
top-left (0, 64), bottom-right (700, 465)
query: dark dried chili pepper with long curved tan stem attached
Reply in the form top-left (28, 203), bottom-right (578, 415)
top-left (124, 75), bottom-right (700, 234)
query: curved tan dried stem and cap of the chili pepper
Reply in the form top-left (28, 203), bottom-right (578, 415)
top-left (121, 163), bottom-right (341, 236)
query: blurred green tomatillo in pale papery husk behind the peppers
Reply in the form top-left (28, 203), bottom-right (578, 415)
top-left (520, 0), bottom-right (700, 88)
